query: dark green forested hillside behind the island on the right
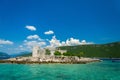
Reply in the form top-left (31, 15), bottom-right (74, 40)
top-left (58, 42), bottom-right (120, 58)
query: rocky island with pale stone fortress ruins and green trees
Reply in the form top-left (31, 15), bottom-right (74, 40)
top-left (0, 46), bottom-right (101, 64)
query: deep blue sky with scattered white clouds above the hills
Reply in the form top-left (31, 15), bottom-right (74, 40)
top-left (0, 0), bottom-right (120, 54)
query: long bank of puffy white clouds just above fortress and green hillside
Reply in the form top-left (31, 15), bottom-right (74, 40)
top-left (19, 35), bottom-right (93, 50)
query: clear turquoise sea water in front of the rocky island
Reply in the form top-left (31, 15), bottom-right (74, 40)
top-left (0, 61), bottom-right (120, 80)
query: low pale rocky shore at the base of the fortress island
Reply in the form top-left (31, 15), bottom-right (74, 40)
top-left (0, 57), bottom-right (101, 64)
